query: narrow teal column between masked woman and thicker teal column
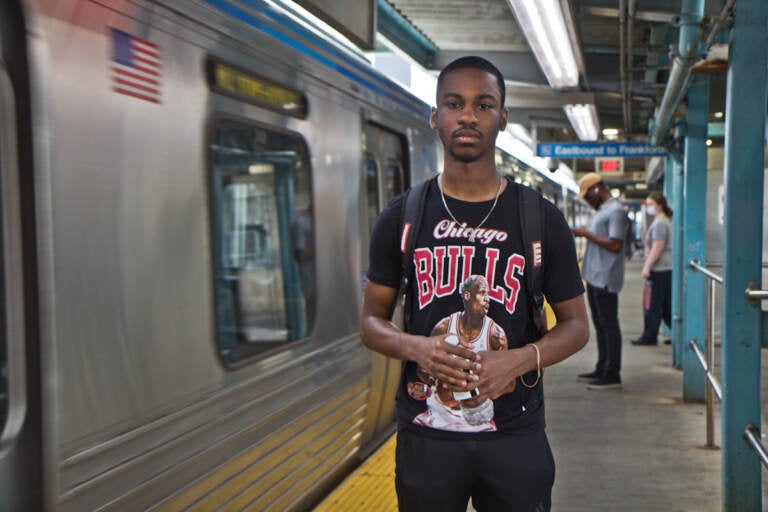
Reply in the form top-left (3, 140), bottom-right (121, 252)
top-left (669, 148), bottom-right (685, 368)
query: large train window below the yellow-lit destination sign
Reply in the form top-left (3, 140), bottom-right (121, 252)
top-left (209, 120), bottom-right (316, 364)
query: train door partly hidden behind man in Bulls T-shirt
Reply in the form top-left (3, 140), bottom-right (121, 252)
top-left (360, 123), bottom-right (409, 444)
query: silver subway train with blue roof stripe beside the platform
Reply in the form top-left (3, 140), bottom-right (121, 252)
top-left (0, 0), bottom-right (576, 512)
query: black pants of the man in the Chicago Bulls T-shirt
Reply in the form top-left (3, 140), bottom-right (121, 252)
top-left (395, 429), bottom-right (555, 512)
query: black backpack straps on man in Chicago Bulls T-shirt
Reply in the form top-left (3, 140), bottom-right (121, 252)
top-left (400, 177), bottom-right (545, 338)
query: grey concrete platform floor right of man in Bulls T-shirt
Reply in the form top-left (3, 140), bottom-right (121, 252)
top-left (544, 255), bottom-right (722, 512)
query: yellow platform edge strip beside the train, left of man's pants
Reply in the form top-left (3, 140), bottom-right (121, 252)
top-left (314, 435), bottom-right (397, 512)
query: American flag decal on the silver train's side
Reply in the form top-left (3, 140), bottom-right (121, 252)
top-left (110, 28), bottom-right (162, 103)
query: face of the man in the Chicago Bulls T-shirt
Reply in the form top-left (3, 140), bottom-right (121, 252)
top-left (430, 68), bottom-right (507, 163)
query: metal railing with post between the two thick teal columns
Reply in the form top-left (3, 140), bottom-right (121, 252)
top-left (689, 260), bottom-right (723, 448)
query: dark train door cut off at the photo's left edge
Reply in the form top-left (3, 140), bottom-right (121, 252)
top-left (0, 2), bottom-right (43, 512)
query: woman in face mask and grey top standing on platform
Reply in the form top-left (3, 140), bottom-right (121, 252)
top-left (632, 192), bottom-right (672, 345)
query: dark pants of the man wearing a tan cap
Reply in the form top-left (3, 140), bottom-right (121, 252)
top-left (587, 283), bottom-right (621, 377)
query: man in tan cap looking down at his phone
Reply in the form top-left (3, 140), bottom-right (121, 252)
top-left (573, 172), bottom-right (627, 389)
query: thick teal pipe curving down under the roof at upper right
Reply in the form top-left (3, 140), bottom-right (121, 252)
top-left (650, 0), bottom-right (704, 146)
